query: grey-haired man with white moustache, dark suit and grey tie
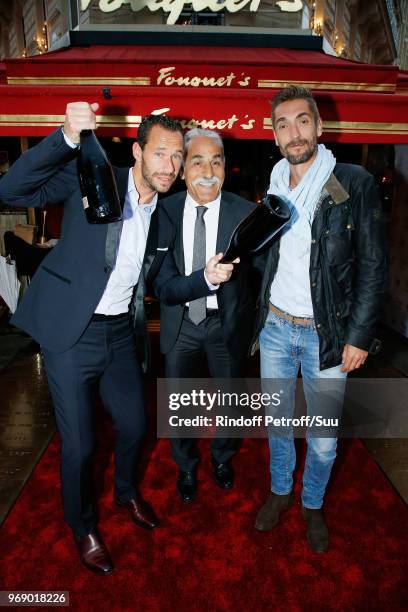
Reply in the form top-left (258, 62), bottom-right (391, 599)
top-left (154, 129), bottom-right (259, 502)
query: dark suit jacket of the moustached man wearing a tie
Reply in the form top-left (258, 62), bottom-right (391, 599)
top-left (153, 191), bottom-right (262, 357)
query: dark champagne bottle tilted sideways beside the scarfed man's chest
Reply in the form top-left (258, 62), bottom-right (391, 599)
top-left (220, 194), bottom-right (291, 263)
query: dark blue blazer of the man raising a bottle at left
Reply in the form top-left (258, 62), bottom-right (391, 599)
top-left (0, 129), bottom-right (173, 352)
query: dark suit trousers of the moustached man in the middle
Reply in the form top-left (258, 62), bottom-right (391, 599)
top-left (165, 308), bottom-right (244, 472)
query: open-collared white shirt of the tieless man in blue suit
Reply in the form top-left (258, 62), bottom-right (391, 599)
top-left (95, 168), bottom-right (157, 315)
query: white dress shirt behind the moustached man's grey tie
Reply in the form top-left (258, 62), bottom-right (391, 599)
top-left (183, 193), bottom-right (221, 309)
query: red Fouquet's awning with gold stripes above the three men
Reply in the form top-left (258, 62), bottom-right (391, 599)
top-left (0, 46), bottom-right (408, 143)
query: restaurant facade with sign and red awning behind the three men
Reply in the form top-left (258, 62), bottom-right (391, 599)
top-left (0, 0), bottom-right (408, 335)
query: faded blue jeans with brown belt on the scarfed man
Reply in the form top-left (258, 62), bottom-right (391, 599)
top-left (260, 311), bottom-right (347, 509)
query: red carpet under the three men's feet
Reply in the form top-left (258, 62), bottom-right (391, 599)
top-left (0, 424), bottom-right (408, 612)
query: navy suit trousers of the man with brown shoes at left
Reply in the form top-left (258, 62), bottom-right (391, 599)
top-left (42, 314), bottom-right (146, 537)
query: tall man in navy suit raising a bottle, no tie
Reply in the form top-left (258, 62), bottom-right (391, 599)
top-left (0, 102), bottom-right (188, 574)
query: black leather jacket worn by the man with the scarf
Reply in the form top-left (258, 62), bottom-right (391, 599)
top-left (256, 164), bottom-right (387, 370)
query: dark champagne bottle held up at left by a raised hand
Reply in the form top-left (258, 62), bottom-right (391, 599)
top-left (78, 130), bottom-right (122, 223)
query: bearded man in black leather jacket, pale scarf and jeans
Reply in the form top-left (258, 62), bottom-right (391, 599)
top-left (255, 86), bottom-right (387, 552)
